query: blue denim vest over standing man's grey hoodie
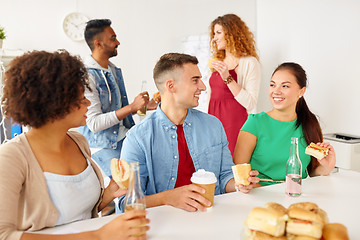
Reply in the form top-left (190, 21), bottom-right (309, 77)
top-left (78, 61), bottom-right (135, 149)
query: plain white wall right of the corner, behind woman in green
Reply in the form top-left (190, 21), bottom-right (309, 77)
top-left (257, 0), bottom-right (360, 136)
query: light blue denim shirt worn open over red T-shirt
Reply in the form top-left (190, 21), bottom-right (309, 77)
top-left (120, 106), bottom-right (234, 208)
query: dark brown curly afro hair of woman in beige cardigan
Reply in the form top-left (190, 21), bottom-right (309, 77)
top-left (1, 50), bottom-right (89, 128)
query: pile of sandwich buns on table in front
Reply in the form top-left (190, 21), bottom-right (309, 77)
top-left (244, 202), bottom-right (349, 240)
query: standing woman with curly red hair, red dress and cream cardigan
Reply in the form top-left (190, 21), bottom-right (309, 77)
top-left (208, 14), bottom-right (261, 155)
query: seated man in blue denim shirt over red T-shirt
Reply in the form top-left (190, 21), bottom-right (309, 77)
top-left (119, 53), bottom-right (239, 211)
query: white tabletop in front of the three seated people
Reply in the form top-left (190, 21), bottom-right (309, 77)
top-left (41, 170), bottom-right (360, 240)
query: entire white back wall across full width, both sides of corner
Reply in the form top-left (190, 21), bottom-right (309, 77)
top-left (0, 0), bottom-right (360, 135)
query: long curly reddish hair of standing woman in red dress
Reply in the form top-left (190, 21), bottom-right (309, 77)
top-left (210, 14), bottom-right (259, 60)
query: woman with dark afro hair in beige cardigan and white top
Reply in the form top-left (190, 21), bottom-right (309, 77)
top-left (0, 51), bottom-right (148, 240)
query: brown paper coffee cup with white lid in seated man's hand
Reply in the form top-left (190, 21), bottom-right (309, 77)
top-left (190, 169), bottom-right (217, 207)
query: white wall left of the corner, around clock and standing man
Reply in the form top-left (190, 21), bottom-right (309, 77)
top-left (0, 0), bottom-right (256, 102)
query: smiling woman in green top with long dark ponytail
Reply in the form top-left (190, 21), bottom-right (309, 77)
top-left (234, 63), bottom-right (336, 193)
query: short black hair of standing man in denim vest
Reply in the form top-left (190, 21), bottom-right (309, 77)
top-left (84, 19), bottom-right (111, 51)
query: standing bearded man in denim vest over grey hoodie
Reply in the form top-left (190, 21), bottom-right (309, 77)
top-left (79, 19), bottom-right (149, 176)
